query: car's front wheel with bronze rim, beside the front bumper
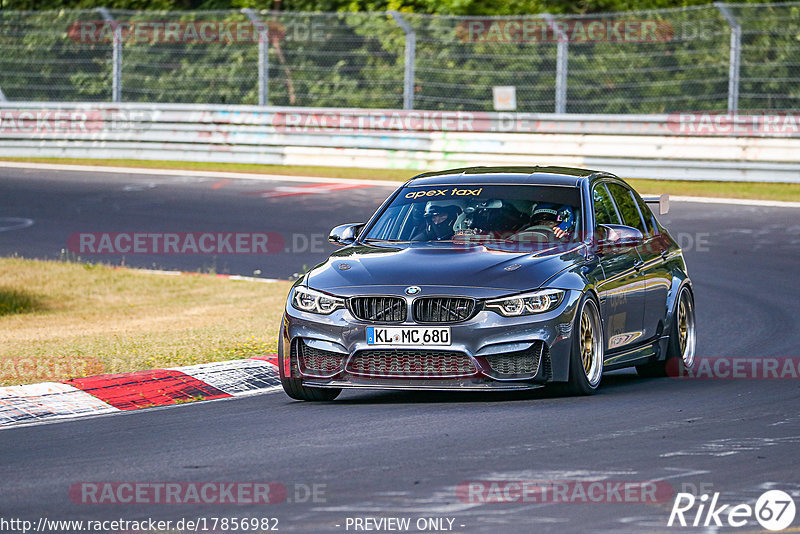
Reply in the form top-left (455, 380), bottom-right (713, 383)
top-left (555, 295), bottom-right (605, 396)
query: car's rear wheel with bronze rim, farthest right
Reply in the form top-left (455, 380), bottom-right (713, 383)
top-left (636, 286), bottom-right (697, 378)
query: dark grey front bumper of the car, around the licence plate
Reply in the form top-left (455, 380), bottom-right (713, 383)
top-left (279, 291), bottom-right (581, 391)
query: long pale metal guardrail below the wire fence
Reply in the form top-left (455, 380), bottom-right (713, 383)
top-left (0, 102), bottom-right (800, 183)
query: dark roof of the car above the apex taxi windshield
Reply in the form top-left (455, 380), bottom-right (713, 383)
top-left (408, 166), bottom-right (610, 186)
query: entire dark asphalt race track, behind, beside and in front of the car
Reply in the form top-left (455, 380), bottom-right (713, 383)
top-left (0, 169), bottom-right (800, 533)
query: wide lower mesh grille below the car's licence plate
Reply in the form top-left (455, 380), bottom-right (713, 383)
top-left (346, 350), bottom-right (476, 378)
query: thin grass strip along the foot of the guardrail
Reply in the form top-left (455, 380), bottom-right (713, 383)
top-left (0, 158), bottom-right (800, 202)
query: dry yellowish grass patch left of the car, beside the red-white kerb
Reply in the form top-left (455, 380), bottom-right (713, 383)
top-left (0, 258), bottom-right (291, 385)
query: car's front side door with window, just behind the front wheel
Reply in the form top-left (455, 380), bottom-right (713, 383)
top-left (592, 182), bottom-right (644, 363)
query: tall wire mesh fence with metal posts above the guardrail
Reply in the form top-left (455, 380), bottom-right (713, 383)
top-left (0, 2), bottom-right (800, 113)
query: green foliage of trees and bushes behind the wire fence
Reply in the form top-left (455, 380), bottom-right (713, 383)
top-left (0, 0), bottom-right (800, 113)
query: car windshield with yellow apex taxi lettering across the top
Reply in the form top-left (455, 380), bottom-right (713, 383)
top-left (363, 183), bottom-right (581, 243)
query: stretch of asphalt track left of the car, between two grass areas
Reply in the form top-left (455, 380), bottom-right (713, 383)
top-left (0, 169), bottom-right (391, 279)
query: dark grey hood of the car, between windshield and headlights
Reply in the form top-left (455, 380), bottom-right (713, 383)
top-left (305, 243), bottom-right (584, 298)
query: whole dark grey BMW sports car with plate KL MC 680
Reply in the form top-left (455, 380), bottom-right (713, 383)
top-left (279, 167), bottom-right (695, 400)
